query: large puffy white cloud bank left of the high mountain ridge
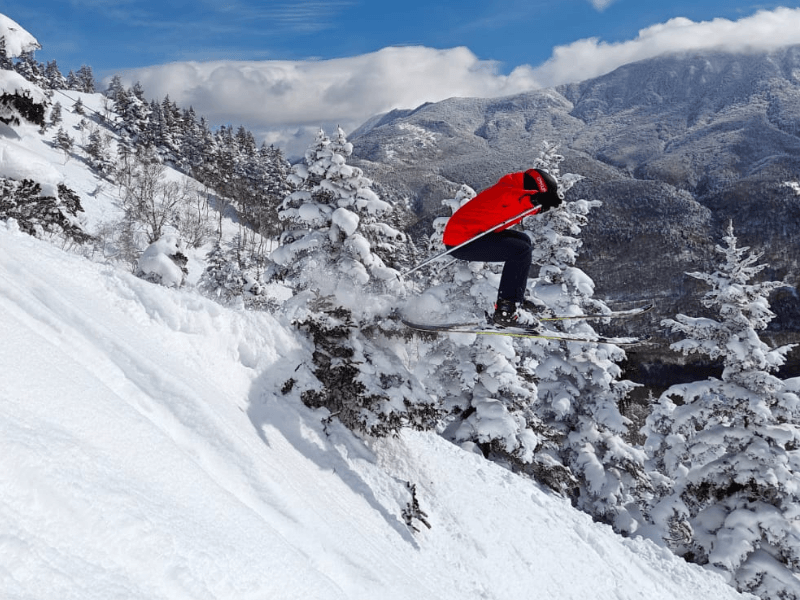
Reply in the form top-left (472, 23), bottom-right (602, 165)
top-left (122, 47), bottom-right (537, 152)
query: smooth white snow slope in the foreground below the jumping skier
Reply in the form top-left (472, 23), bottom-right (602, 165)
top-left (0, 221), bottom-right (752, 600)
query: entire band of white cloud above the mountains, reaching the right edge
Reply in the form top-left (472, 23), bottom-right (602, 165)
top-left (114, 8), bottom-right (800, 154)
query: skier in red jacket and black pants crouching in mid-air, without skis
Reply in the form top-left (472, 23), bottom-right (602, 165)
top-left (442, 169), bottom-right (561, 327)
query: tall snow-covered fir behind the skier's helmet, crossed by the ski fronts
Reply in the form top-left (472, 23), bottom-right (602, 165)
top-left (525, 144), bottom-right (651, 533)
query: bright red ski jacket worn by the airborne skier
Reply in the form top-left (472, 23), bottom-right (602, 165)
top-left (442, 172), bottom-right (547, 247)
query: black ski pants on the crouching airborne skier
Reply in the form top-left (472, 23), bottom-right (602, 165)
top-left (450, 229), bottom-right (533, 303)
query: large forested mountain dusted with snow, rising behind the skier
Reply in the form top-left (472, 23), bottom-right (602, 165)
top-left (351, 47), bottom-right (800, 360)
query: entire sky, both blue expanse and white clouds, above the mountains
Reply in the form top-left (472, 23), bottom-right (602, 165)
top-left (0, 0), bottom-right (800, 155)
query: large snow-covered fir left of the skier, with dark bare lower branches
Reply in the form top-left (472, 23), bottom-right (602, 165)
top-left (271, 129), bottom-right (438, 435)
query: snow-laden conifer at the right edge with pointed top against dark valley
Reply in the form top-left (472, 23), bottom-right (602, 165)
top-left (644, 225), bottom-right (800, 600)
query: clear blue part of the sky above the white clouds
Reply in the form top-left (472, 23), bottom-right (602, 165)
top-left (0, 0), bottom-right (800, 75)
